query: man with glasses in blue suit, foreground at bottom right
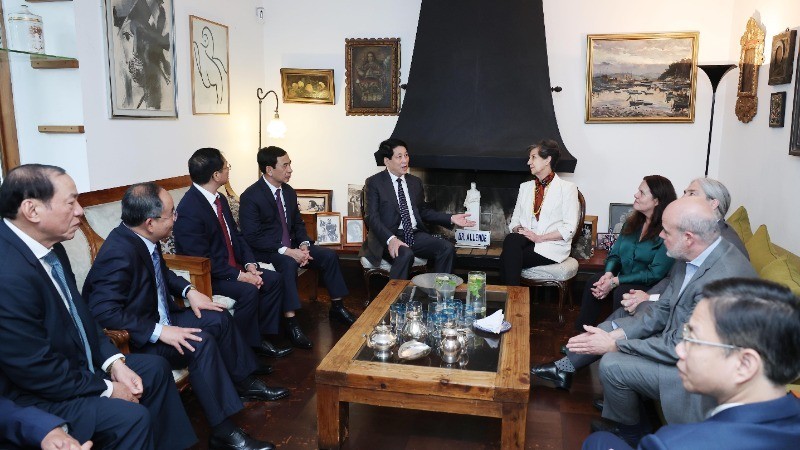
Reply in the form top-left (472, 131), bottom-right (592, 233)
top-left (583, 278), bottom-right (800, 450)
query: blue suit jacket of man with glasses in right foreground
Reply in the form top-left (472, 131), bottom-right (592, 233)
top-left (639, 394), bottom-right (800, 450)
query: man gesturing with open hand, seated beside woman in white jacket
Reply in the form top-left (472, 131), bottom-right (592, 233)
top-left (359, 138), bottom-right (475, 280)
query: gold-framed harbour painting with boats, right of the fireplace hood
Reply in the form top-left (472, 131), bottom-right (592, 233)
top-left (586, 32), bottom-right (699, 123)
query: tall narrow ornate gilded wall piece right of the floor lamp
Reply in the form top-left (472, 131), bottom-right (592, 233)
top-left (736, 17), bottom-right (765, 123)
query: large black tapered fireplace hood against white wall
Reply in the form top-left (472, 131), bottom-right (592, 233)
top-left (388, 0), bottom-right (577, 172)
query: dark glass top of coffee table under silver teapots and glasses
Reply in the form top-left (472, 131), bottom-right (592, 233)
top-left (355, 285), bottom-right (508, 372)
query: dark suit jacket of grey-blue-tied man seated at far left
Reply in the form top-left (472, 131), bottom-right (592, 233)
top-left (0, 220), bottom-right (119, 408)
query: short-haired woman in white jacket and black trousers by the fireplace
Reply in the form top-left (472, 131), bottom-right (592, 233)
top-left (500, 140), bottom-right (580, 286)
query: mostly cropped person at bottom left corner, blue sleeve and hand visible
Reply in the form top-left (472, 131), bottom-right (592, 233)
top-left (0, 396), bottom-right (92, 450)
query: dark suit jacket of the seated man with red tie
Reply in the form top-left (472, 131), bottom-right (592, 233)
top-left (172, 185), bottom-right (256, 280)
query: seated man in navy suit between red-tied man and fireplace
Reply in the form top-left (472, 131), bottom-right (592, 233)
top-left (239, 147), bottom-right (355, 325)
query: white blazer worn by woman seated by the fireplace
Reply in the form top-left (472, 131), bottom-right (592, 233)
top-left (508, 175), bottom-right (580, 262)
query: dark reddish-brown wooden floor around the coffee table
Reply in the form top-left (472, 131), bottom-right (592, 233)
top-left (183, 261), bottom-right (602, 450)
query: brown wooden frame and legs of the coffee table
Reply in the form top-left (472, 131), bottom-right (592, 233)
top-left (316, 280), bottom-right (530, 449)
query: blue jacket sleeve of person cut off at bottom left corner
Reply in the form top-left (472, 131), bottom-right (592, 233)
top-left (0, 397), bottom-right (65, 448)
